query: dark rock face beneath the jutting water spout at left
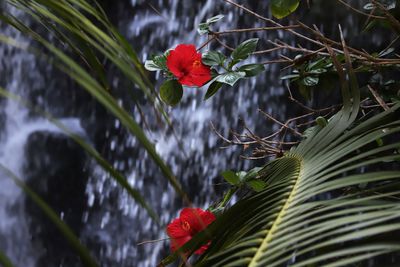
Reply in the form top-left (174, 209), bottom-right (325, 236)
top-left (24, 132), bottom-right (88, 266)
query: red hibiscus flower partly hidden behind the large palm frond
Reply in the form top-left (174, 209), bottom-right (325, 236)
top-left (167, 208), bottom-right (215, 254)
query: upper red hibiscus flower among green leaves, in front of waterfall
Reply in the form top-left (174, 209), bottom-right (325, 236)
top-left (167, 44), bottom-right (211, 86)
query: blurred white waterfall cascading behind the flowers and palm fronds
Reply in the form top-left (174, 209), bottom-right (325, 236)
top-left (0, 0), bottom-right (388, 267)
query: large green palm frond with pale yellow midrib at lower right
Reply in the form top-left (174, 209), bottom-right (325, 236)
top-left (160, 44), bottom-right (400, 267)
